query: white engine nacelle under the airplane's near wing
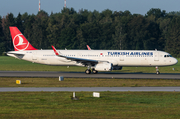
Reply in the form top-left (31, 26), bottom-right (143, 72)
top-left (94, 62), bottom-right (113, 71)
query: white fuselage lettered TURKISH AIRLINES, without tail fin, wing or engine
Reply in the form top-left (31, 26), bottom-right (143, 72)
top-left (7, 50), bottom-right (177, 66)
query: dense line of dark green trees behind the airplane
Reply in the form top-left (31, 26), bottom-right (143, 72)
top-left (0, 8), bottom-right (180, 57)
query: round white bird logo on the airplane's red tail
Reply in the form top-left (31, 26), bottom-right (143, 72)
top-left (13, 34), bottom-right (29, 50)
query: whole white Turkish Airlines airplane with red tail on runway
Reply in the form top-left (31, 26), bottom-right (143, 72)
top-left (7, 26), bottom-right (178, 74)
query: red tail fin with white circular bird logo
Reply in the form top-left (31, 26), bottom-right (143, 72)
top-left (9, 27), bottom-right (37, 51)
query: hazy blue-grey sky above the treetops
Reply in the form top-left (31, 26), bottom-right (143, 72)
top-left (0, 0), bottom-right (180, 16)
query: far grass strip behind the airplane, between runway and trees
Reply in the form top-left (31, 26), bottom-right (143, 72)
top-left (0, 56), bottom-right (180, 73)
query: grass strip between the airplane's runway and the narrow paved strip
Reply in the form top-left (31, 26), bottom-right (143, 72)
top-left (0, 77), bottom-right (180, 87)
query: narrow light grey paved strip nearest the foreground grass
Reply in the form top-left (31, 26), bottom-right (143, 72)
top-left (0, 87), bottom-right (180, 92)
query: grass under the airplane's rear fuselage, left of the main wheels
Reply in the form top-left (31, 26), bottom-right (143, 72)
top-left (0, 56), bottom-right (86, 71)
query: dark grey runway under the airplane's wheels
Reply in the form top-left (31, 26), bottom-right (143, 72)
top-left (0, 71), bottom-right (180, 79)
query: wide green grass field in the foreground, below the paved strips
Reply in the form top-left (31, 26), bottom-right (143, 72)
top-left (0, 92), bottom-right (180, 119)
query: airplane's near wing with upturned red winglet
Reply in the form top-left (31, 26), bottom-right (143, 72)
top-left (52, 46), bottom-right (104, 66)
